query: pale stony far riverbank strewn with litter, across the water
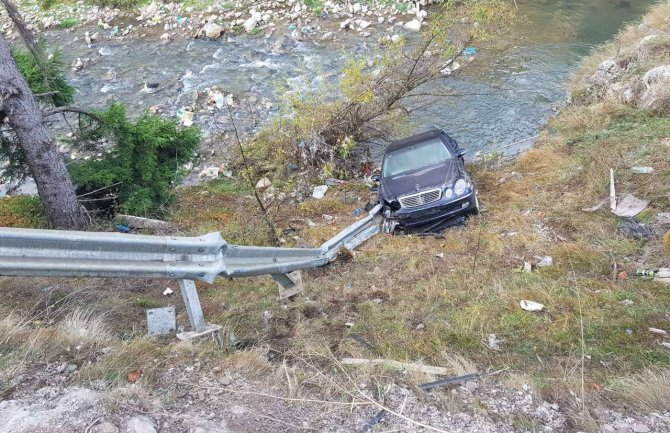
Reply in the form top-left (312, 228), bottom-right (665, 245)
top-left (0, 0), bottom-right (444, 43)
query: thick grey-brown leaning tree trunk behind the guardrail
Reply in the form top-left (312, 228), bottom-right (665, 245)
top-left (0, 36), bottom-right (86, 229)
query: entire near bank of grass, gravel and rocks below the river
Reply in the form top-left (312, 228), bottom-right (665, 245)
top-left (0, 2), bottom-right (670, 433)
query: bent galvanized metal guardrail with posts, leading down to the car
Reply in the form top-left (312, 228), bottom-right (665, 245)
top-left (0, 204), bottom-right (382, 340)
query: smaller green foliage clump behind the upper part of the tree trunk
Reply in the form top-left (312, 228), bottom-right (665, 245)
top-left (12, 42), bottom-right (74, 107)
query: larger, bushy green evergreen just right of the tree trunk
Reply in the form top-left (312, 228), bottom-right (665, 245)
top-left (68, 104), bottom-right (201, 216)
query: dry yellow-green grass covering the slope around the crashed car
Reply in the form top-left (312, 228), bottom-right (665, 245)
top-left (0, 0), bottom-right (670, 418)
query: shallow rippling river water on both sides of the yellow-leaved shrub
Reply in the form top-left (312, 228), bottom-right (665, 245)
top-left (51, 0), bottom-right (653, 159)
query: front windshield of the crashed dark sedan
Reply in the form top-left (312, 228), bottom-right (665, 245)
top-left (382, 138), bottom-right (452, 177)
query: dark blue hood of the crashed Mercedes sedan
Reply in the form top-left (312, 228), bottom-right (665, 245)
top-left (381, 159), bottom-right (459, 201)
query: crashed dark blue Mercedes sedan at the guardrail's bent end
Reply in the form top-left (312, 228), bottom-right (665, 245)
top-left (379, 130), bottom-right (479, 233)
